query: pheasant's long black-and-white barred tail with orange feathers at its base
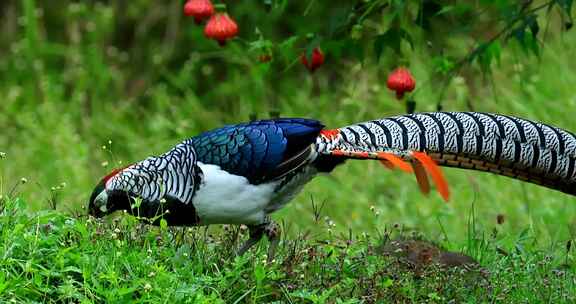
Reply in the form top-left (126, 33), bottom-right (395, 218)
top-left (317, 112), bottom-right (576, 199)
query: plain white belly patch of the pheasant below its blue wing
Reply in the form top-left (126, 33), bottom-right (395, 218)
top-left (192, 163), bottom-right (278, 225)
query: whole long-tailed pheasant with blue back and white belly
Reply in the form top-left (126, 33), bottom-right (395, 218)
top-left (89, 112), bottom-right (576, 258)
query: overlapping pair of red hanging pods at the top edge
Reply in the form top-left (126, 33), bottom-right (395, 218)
top-left (184, 0), bottom-right (238, 46)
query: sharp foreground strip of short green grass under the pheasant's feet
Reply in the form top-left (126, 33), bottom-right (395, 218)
top-left (0, 199), bottom-right (576, 303)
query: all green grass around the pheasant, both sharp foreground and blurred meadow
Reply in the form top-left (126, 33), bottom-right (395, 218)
top-left (0, 0), bottom-right (576, 303)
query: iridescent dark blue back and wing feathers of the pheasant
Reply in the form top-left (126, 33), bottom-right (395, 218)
top-left (191, 118), bottom-right (324, 184)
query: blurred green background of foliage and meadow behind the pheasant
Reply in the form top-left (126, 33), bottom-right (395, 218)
top-left (0, 0), bottom-right (576, 246)
